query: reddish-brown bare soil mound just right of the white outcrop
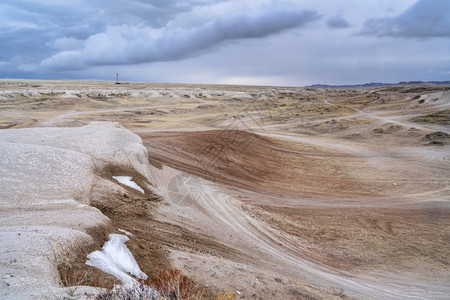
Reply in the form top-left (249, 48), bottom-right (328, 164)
top-left (140, 130), bottom-right (367, 197)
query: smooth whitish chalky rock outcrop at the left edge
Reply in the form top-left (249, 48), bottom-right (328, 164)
top-left (0, 123), bottom-right (150, 299)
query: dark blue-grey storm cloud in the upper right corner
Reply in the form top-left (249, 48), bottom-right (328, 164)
top-left (362, 0), bottom-right (450, 38)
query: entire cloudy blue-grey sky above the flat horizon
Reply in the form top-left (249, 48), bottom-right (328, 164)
top-left (0, 0), bottom-right (450, 86)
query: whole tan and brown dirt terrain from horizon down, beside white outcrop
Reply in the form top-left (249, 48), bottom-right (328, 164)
top-left (0, 81), bottom-right (450, 299)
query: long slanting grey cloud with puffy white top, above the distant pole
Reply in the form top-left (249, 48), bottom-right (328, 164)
top-left (41, 3), bottom-right (319, 70)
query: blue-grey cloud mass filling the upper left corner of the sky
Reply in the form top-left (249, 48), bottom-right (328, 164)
top-left (0, 0), bottom-right (230, 74)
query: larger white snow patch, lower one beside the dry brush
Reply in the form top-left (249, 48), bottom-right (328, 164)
top-left (86, 233), bottom-right (147, 286)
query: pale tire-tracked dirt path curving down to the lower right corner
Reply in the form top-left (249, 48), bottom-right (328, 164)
top-left (153, 169), bottom-right (444, 299)
